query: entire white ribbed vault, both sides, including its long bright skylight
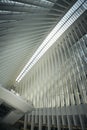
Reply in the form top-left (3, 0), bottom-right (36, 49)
top-left (0, 0), bottom-right (87, 107)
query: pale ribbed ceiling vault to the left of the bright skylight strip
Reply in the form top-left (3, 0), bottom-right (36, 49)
top-left (0, 0), bottom-right (76, 87)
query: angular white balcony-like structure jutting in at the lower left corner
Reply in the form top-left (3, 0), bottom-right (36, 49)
top-left (0, 85), bottom-right (34, 124)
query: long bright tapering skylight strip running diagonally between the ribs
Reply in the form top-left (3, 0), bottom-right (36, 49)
top-left (16, 0), bottom-right (87, 82)
